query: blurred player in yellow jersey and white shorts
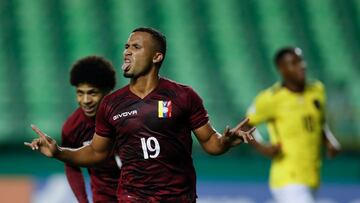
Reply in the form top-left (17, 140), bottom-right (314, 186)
top-left (247, 47), bottom-right (340, 203)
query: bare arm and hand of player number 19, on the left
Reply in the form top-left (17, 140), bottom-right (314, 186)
top-left (24, 125), bottom-right (113, 167)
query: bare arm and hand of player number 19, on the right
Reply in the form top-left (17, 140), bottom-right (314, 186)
top-left (194, 119), bottom-right (255, 155)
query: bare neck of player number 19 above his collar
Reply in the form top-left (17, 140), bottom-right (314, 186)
top-left (129, 72), bottom-right (160, 99)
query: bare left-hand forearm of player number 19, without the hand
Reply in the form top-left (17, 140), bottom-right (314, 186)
top-left (55, 145), bottom-right (108, 167)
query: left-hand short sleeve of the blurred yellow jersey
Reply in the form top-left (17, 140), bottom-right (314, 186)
top-left (246, 91), bottom-right (275, 125)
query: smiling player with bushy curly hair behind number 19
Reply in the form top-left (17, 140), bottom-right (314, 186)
top-left (61, 56), bottom-right (120, 203)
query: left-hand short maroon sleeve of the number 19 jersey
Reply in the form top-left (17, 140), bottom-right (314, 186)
top-left (95, 98), bottom-right (115, 138)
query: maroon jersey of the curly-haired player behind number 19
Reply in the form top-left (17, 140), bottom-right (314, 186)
top-left (62, 108), bottom-right (120, 202)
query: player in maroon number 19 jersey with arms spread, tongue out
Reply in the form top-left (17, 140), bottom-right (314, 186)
top-left (26, 28), bottom-right (254, 202)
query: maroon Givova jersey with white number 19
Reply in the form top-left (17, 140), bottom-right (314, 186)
top-left (96, 78), bottom-right (208, 202)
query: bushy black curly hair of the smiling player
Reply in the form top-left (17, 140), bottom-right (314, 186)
top-left (70, 56), bottom-right (116, 91)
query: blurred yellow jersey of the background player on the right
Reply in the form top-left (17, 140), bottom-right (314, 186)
top-left (247, 81), bottom-right (326, 188)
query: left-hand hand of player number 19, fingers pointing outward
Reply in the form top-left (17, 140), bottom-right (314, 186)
top-left (24, 125), bottom-right (59, 157)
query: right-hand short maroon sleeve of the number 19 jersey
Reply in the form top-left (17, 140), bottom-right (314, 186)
top-left (187, 88), bottom-right (209, 130)
